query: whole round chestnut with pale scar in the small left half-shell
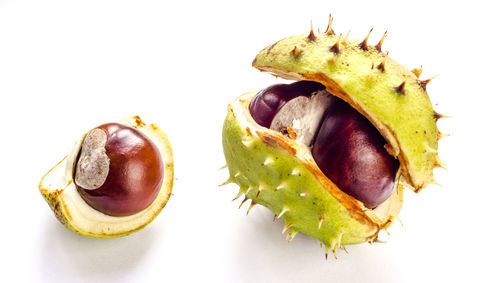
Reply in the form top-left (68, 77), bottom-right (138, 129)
top-left (75, 123), bottom-right (164, 216)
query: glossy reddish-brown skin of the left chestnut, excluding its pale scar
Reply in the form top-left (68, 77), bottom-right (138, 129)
top-left (75, 123), bottom-right (164, 219)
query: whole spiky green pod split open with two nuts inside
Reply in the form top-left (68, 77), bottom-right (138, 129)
top-left (223, 18), bottom-right (442, 258)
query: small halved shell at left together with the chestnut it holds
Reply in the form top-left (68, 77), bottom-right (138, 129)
top-left (39, 116), bottom-right (174, 238)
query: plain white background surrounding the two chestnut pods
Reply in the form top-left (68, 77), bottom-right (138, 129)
top-left (0, 0), bottom-right (500, 282)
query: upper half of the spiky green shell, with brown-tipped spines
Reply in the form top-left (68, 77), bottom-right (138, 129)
top-left (253, 29), bottom-right (441, 191)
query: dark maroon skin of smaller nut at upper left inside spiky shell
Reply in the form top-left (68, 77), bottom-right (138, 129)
top-left (250, 81), bottom-right (325, 128)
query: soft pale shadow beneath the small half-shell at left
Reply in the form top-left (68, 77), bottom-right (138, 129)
top-left (38, 216), bottom-right (161, 282)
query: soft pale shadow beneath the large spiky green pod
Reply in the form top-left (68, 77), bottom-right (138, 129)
top-left (232, 207), bottom-right (397, 283)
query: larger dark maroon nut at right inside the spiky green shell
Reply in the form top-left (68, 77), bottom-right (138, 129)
top-left (312, 98), bottom-right (399, 208)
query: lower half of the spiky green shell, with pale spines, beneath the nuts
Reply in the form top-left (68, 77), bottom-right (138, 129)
top-left (223, 92), bottom-right (402, 249)
